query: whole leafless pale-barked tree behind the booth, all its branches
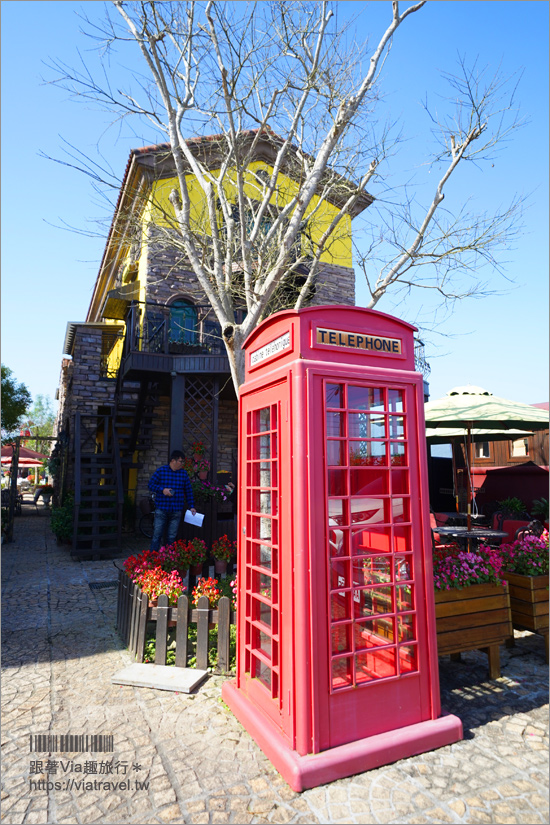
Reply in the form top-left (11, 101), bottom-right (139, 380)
top-left (48, 0), bottom-right (528, 387)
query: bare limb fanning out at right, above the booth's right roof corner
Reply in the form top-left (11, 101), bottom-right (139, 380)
top-left (356, 59), bottom-right (524, 318)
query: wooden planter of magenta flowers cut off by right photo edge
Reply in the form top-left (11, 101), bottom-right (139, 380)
top-left (500, 530), bottom-right (549, 661)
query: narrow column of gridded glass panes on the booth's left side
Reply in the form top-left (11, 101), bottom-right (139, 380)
top-left (245, 404), bottom-right (280, 699)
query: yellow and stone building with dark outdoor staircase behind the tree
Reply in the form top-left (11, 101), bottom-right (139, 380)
top-left (56, 133), bottom-right (372, 552)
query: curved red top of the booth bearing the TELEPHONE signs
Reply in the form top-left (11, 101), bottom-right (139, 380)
top-left (244, 306), bottom-right (416, 379)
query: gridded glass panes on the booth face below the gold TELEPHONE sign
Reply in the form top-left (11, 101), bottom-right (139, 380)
top-left (324, 382), bottom-right (418, 691)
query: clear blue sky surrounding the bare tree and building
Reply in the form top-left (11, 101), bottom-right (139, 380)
top-left (1, 0), bottom-right (549, 403)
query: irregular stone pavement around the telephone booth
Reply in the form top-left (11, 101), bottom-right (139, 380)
top-left (1, 507), bottom-right (548, 825)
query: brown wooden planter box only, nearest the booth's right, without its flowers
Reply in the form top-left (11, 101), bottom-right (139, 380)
top-left (435, 584), bottom-right (513, 679)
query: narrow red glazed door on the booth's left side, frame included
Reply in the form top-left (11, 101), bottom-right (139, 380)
top-left (237, 381), bottom-right (292, 736)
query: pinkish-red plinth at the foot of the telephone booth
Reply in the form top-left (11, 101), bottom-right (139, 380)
top-left (222, 681), bottom-right (463, 792)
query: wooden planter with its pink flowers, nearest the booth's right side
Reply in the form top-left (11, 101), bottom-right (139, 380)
top-left (433, 545), bottom-right (513, 679)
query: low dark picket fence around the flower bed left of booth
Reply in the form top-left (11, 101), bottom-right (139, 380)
top-left (117, 570), bottom-right (237, 673)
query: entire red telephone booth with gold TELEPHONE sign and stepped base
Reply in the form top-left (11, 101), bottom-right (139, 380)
top-left (222, 306), bottom-right (462, 790)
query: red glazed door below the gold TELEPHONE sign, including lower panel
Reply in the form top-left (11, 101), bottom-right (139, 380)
top-left (312, 377), bottom-right (432, 748)
